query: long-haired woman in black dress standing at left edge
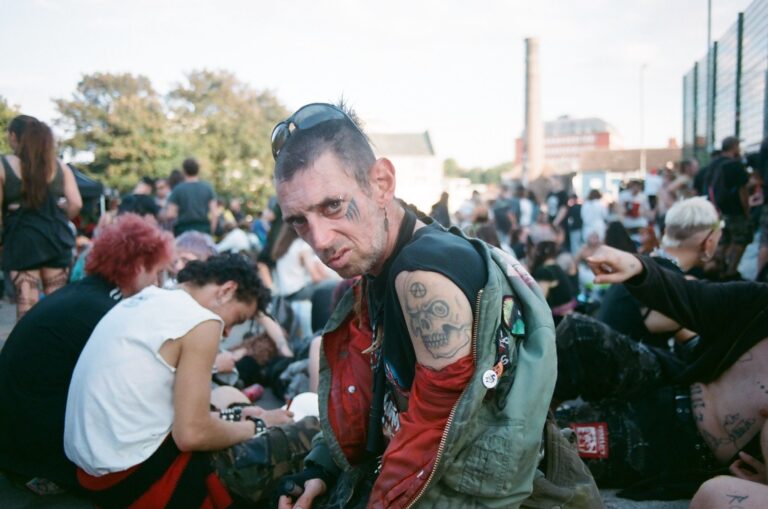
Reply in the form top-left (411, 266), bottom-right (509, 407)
top-left (0, 115), bottom-right (83, 321)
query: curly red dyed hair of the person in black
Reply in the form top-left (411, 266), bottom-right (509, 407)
top-left (85, 214), bottom-right (173, 289)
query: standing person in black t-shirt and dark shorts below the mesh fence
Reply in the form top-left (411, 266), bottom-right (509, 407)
top-left (706, 136), bottom-right (752, 278)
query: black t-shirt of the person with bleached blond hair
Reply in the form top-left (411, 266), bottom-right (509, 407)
top-left (597, 258), bottom-right (681, 349)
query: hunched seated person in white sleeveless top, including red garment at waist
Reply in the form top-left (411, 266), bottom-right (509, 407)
top-left (64, 255), bottom-right (317, 507)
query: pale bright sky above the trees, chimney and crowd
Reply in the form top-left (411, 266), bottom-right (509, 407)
top-left (0, 0), bottom-right (751, 166)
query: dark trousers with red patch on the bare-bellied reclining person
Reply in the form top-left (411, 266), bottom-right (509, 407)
top-left (555, 314), bottom-right (719, 497)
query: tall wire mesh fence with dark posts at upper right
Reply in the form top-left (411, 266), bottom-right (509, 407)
top-left (683, 0), bottom-right (768, 161)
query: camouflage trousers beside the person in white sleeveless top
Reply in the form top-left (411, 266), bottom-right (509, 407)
top-left (212, 417), bottom-right (320, 507)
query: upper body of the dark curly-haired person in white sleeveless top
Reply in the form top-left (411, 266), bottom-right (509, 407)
top-left (64, 255), bottom-right (291, 504)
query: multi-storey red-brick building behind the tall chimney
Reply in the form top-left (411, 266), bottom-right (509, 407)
top-left (515, 116), bottom-right (621, 175)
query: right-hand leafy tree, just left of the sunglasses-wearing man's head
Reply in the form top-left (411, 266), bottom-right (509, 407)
top-left (168, 70), bottom-right (287, 203)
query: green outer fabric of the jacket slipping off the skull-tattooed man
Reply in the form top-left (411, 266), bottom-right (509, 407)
top-left (308, 228), bottom-right (557, 508)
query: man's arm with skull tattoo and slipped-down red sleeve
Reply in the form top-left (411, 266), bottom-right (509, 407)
top-left (368, 271), bottom-right (474, 507)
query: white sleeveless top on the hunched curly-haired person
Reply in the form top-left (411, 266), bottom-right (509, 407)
top-left (64, 286), bottom-right (223, 476)
